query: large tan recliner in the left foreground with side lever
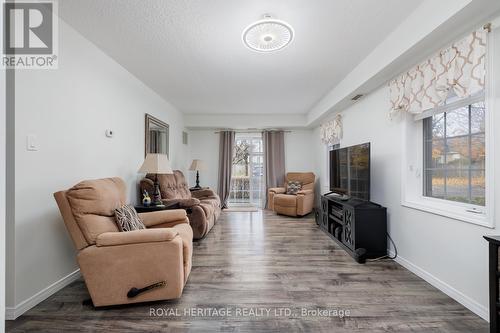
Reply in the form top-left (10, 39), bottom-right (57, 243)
top-left (54, 178), bottom-right (193, 306)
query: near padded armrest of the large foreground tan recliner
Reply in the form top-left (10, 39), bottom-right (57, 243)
top-left (96, 228), bottom-right (179, 247)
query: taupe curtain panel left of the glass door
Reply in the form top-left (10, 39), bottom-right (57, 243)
top-left (218, 131), bottom-right (235, 208)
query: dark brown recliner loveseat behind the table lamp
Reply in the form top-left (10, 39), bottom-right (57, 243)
top-left (141, 170), bottom-right (221, 239)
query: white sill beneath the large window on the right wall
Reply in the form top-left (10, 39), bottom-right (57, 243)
top-left (401, 197), bottom-right (494, 229)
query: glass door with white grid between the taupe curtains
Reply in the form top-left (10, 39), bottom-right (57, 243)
top-left (229, 133), bottom-right (264, 207)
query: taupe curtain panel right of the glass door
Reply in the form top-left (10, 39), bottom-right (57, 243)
top-left (262, 131), bottom-right (285, 208)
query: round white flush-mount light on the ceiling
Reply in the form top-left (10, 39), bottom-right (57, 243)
top-left (242, 14), bottom-right (295, 52)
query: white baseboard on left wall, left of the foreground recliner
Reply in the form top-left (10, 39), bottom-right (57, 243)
top-left (5, 269), bottom-right (81, 320)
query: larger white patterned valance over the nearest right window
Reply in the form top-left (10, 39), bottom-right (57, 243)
top-left (389, 29), bottom-right (488, 115)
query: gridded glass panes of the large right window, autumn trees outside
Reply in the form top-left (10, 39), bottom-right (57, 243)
top-left (423, 94), bottom-right (486, 207)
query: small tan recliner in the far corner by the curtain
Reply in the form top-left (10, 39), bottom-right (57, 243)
top-left (268, 172), bottom-right (315, 216)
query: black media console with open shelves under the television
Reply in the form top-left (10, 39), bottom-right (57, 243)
top-left (317, 195), bottom-right (387, 263)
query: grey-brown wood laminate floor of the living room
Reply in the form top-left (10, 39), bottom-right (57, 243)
top-left (7, 211), bottom-right (488, 332)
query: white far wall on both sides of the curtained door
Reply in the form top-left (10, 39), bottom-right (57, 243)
top-left (189, 129), bottom-right (316, 189)
